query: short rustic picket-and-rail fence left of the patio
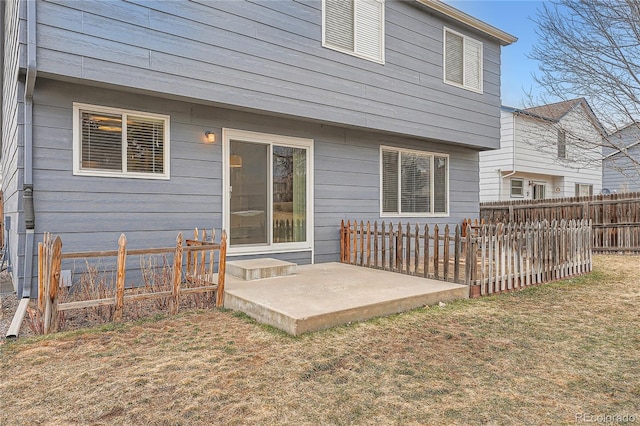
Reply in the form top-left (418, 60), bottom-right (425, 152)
top-left (37, 229), bottom-right (227, 334)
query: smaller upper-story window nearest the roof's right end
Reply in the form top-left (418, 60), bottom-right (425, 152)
top-left (443, 28), bottom-right (482, 93)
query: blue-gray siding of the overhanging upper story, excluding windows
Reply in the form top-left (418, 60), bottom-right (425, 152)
top-left (37, 0), bottom-right (500, 149)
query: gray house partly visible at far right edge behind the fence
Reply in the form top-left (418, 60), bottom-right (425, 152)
top-left (602, 122), bottom-right (640, 192)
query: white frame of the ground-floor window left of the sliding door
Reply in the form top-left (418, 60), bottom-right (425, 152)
top-left (73, 102), bottom-right (171, 180)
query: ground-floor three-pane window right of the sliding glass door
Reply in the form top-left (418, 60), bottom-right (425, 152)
top-left (380, 147), bottom-right (449, 216)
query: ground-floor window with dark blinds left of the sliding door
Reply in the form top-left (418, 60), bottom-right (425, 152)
top-left (73, 104), bottom-right (169, 179)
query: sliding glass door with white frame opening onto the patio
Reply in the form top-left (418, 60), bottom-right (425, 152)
top-left (225, 130), bottom-right (312, 251)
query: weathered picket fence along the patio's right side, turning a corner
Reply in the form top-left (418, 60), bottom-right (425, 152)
top-left (340, 221), bottom-right (592, 295)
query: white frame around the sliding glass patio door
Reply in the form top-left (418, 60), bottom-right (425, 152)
top-left (222, 128), bottom-right (314, 256)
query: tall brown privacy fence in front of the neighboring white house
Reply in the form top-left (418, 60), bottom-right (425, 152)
top-left (480, 192), bottom-right (640, 253)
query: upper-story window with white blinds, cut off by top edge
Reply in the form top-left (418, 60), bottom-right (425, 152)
top-left (322, 0), bottom-right (384, 63)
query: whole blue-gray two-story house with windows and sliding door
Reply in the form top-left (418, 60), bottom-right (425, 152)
top-left (1, 0), bottom-right (515, 295)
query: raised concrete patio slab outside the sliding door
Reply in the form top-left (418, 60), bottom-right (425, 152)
top-left (224, 263), bottom-right (469, 336)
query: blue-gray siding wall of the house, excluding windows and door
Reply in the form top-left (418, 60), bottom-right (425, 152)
top-left (2, 0), bottom-right (502, 294)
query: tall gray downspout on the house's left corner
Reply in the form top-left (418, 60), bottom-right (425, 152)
top-left (22, 1), bottom-right (37, 298)
